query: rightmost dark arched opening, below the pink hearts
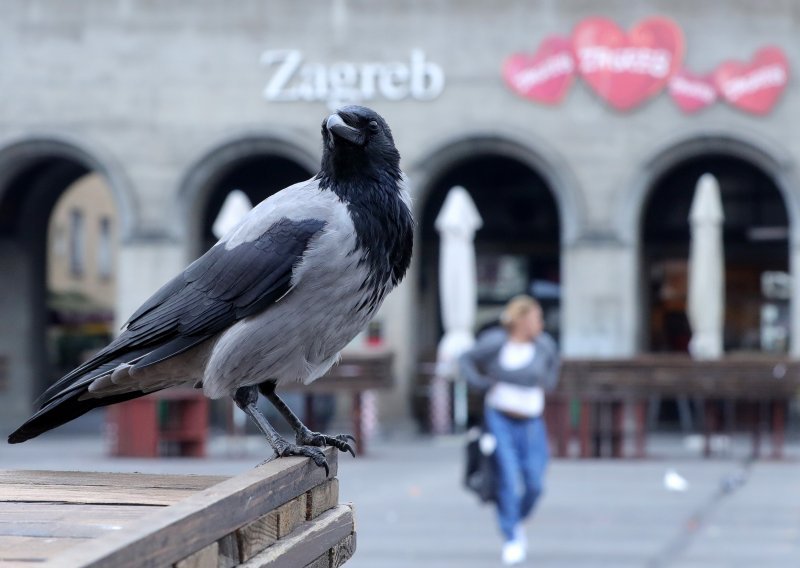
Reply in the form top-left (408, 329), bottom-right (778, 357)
top-left (642, 154), bottom-right (789, 352)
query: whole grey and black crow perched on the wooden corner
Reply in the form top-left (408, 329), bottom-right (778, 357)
top-left (8, 106), bottom-right (413, 465)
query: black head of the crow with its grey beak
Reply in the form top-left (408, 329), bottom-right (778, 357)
top-left (320, 105), bottom-right (402, 189)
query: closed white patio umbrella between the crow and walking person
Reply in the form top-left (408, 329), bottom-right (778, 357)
top-left (431, 186), bottom-right (483, 433)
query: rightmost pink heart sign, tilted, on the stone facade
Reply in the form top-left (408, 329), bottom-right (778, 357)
top-left (714, 47), bottom-right (789, 115)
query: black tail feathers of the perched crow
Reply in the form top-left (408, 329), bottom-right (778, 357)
top-left (8, 389), bottom-right (145, 444)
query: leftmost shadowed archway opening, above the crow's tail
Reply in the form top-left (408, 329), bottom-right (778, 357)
top-left (0, 151), bottom-right (116, 406)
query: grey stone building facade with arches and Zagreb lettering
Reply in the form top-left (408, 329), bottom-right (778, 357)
top-left (0, 0), bottom-right (800, 432)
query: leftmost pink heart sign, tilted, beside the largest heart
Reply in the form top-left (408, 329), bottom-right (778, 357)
top-left (503, 36), bottom-right (575, 105)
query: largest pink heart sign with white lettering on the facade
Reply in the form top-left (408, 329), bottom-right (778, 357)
top-left (572, 16), bottom-right (683, 110)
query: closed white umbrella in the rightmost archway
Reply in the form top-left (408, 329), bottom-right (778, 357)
top-left (687, 174), bottom-right (725, 359)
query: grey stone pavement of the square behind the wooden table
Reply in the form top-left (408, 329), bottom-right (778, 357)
top-left (0, 433), bottom-right (800, 568)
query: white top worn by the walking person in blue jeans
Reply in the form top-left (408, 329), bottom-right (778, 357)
top-left (486, 341), bottom-right (544, 418)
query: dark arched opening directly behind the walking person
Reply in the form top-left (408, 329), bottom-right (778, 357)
top-left (412, 152), bottom-right (561, 430)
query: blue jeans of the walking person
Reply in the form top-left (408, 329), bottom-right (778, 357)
top-left (485, 407), bottom-right (550, 540)
